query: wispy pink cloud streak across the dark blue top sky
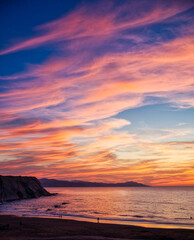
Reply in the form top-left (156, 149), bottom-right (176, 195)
top-left (0, 1), bottom-right (193, 55)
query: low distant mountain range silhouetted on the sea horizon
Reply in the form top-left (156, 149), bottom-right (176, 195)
top-left (39, 178), bottom-right (148, 187)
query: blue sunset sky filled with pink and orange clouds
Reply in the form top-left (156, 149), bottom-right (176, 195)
top-left (0, 0), bottom-right (194, 186)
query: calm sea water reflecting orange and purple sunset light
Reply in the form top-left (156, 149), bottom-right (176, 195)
top-left (0, 187), bottom-right (194, 228)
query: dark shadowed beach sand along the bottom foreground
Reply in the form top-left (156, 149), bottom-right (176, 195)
top-left (0, 215), bottom-right (194, 240)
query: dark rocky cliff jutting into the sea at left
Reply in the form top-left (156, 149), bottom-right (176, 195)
top-left (0, 175), bottom-right (51, 202)
